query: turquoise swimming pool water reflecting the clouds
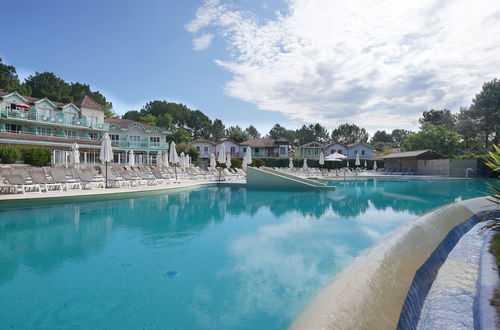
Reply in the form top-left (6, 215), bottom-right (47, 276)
top-left (0, 179), bottom-right (492, 329)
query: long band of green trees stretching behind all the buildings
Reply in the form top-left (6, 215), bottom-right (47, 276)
top-left (0, 59), bottom-right (500, 156)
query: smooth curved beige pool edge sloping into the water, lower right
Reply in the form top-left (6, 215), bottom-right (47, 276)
top-left (290, 197), bottom-right (492, 329)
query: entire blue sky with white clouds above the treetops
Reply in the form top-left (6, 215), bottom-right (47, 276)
top-left (0, 0), bottom-right (500, 132)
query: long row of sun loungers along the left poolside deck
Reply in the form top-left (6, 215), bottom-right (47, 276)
top-left (0, 165), bottom-right (246, 193)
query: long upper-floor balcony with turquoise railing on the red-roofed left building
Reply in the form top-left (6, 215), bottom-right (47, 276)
top-left (0, 108), bottom-right (109, 131)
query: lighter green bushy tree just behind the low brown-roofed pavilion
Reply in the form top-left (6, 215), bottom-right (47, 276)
top-left (403, 124), bottom-right (461, 156)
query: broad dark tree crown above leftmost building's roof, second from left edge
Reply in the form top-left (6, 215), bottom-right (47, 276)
top-left (23, 72), bottom-right (73, 103)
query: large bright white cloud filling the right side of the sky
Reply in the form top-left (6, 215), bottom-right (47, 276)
top-left (186, 0), bottom-right (500, 130)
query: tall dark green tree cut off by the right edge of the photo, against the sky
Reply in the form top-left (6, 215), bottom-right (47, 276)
top-left (470, 79), bottom-right (500, 148)
